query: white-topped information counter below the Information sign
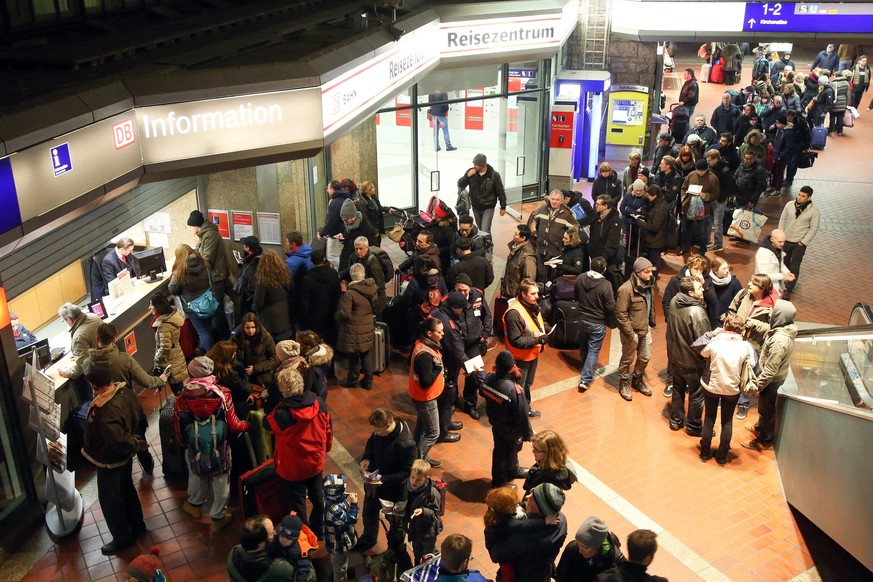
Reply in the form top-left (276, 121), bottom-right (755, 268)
top-left (46, 271), bottom-right (170, 426)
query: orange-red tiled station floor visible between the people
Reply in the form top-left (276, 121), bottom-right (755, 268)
top-left (15, 49), bottom-right (873, 582)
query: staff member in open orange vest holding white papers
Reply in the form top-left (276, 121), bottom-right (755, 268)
top-left (503, 279), bottom-right (548, 418)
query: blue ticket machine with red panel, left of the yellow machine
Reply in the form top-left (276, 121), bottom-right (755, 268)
top-left (549, 71), bottom-right (610, 181)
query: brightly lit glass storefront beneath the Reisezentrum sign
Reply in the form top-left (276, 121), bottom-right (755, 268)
top-left (376, 61), bottom-right (547, 214)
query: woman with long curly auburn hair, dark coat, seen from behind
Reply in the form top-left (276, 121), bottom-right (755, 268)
top-left (252, 251), bottom-right (294, 341)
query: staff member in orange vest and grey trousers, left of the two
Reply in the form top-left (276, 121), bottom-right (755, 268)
top-left (409, 317), bottom-right (445, 467)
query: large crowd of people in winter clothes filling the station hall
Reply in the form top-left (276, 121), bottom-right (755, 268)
top-left (59, 45), bottom-right (832, 581)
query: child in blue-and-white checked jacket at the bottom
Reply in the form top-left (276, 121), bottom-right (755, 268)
top-left (324, 475), bottom-right (359, 582)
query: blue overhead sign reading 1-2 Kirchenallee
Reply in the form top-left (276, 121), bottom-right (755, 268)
top-left (743, 2), bottom-right (873, 33)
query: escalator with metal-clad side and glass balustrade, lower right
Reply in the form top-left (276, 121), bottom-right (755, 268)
top-left (775, 303), bottom-right (873, 570)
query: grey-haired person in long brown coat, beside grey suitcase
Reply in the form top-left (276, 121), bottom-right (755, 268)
top-left (337, 263), bottom-right (378, 390)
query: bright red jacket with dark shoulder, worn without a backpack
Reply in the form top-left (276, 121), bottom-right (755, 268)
top-left (266, 392), bottom-right (333, 481)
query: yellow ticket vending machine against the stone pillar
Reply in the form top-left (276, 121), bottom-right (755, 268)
top-left (606, 85), bottom-right (649, 160)
